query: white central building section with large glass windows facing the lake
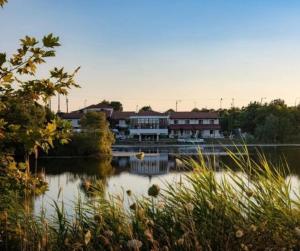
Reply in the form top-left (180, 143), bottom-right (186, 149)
top-left (129, 111), bottom-right (169, 141)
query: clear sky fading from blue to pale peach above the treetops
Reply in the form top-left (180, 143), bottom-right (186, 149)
top-left (0, 0), bottom-right (300, 111)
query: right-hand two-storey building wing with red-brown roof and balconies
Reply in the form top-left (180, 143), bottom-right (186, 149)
top-left (168, 112), bottom-right (221, 139)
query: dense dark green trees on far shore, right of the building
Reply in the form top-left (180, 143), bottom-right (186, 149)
top-left (219, 99), bottom-right (300, 143)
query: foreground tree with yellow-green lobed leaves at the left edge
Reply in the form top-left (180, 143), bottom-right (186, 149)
top-left (0, 34), bottom-right (79, 174)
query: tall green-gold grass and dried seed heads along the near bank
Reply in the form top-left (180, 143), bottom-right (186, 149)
top-left (0, 148), bottom-right (300, 250)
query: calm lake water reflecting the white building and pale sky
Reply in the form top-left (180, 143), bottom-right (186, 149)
top-left (34, 147), bottom-right (300, 214)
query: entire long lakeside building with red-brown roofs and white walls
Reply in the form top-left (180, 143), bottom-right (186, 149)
top-left (60, 103), bottom-right (222, 141)
